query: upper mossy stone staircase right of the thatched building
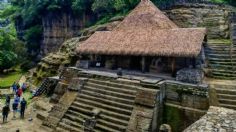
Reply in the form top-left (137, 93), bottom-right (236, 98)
top-left (205, 40), bottom-right (236, 80)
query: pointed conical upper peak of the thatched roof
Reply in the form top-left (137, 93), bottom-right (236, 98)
top-left (114, 0), bottom-right (178, 30)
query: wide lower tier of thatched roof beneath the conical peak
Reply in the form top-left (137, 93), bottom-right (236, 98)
top-left (77, 28), bottom-right (205, 57)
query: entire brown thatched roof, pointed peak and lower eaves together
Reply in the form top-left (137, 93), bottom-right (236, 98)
top-left (77, 0), bottom-right (206, 57)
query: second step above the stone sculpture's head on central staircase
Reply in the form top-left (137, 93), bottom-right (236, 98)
top-left (78, 94), bottom-right (133, 110)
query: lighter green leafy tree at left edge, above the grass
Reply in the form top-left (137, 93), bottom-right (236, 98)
top-left (0, 4), bottom-right (26, 73)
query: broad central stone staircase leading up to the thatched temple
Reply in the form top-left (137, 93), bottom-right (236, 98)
top-left (56, 78), bottom-right (156, 132)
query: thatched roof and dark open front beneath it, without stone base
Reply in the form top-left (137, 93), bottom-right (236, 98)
top-left (77, 0), bottom-right (206, 77)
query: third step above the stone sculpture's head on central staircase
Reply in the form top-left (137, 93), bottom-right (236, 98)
top-left (82, 89), bottom-right (134, 105)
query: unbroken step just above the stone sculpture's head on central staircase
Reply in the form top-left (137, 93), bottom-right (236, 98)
top-left (76, 97), bottom-right (132, 115)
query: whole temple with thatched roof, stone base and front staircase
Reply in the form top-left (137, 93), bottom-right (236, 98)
top-left (37, 0), bottom-right (236, 132)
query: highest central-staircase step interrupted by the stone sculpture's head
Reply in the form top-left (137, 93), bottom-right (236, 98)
top-left (70, 102), bottom-right (130, 121)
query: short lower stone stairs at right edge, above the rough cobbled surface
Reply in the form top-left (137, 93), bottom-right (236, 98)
top-left (211, 84), bottom-right (236, 110)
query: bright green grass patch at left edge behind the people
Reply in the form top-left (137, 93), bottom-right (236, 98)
top-left (0, 71), bottom-right (23, 88)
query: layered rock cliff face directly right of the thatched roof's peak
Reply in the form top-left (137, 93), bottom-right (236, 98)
top-left (165, 4), bottom-right (233, 39)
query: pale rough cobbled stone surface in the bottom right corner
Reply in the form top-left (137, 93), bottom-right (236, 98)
top-left (184, 106), bottom-right (236, 132)
